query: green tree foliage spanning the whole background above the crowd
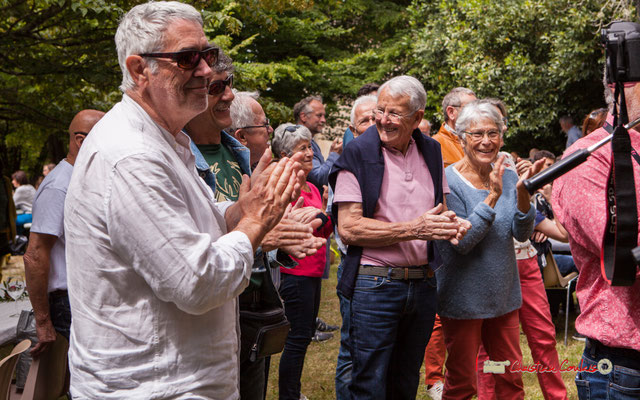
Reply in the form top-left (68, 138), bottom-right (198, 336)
top-left (0, 0), bottom-right (633, 175)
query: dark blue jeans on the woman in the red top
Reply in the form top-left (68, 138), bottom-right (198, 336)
top-left (278, 273), bottom-right (322, 400)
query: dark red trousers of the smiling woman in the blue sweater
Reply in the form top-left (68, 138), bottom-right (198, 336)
top-left (440, 310), bottom-right (524, 400)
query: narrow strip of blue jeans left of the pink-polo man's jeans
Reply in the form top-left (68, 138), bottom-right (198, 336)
top-left (336, 262), bottom-right (352, 400)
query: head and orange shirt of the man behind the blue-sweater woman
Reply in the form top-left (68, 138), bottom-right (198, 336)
top-left (433, 87), bottom-right (476, 168)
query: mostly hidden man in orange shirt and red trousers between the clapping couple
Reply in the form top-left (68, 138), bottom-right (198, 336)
top-left (424, 87), bottom-right (476, 400)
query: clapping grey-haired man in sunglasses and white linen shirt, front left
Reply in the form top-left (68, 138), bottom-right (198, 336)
top-left (65, 2), bottom-right (300, 399)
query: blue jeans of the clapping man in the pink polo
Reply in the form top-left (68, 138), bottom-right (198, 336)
top-left (349, 275), bottom-right (437, 400)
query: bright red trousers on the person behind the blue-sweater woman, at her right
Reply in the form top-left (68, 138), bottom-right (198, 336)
top-left (478, 257), bottom-right (567, 400)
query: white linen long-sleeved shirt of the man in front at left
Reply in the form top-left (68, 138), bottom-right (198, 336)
top-left (65, 95), bottom-right (253, 399)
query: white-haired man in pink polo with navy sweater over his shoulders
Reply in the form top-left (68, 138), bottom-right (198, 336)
top-left (329, 76), bottom-right (470, 399)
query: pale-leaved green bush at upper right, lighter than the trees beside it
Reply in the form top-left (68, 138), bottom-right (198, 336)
top-left (403, 0), bottom-right (632, 152)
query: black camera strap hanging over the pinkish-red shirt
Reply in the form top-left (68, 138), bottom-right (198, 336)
top-left (600, 82), bottom-right (638, 286)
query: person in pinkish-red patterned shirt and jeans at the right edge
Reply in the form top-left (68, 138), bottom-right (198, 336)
top-left (552, 87), bottom-right (640, 400)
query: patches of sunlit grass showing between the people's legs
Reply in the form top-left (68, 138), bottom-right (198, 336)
top-left (267, 258), bottom-right (584, 400)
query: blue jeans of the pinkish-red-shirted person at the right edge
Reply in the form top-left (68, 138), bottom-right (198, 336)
top-left (576, 340), bottom-right (640, 400)
